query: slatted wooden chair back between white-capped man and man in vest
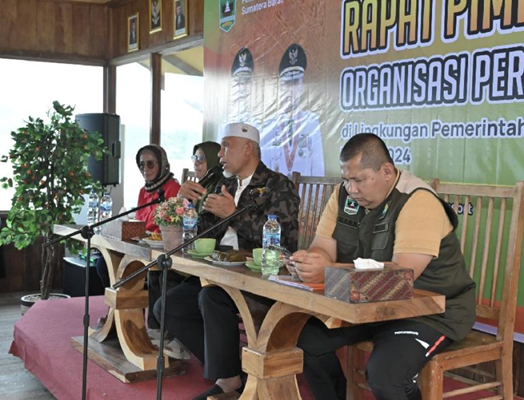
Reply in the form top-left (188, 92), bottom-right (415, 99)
top-left (291, 172), bottom-right (342, 249)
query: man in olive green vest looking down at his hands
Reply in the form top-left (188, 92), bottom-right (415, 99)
top-left (288, 134), bottom-right (475, 400)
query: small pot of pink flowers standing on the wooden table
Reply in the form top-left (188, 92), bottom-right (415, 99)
top-left (154, 197), bottom-right (189, 250)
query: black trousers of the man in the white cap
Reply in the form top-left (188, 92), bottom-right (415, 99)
top-left (154, 277), bottom-right (273, 380)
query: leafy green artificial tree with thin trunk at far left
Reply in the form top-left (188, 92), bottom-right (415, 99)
top-left (0, 101), bottom-right (105, 299)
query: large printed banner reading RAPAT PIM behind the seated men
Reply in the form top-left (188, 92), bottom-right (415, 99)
top-left (204, 0), bottom-right (524, 332)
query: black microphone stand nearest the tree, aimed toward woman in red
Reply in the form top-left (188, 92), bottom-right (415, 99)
top-left (42, 188), bottom-right (165, 400)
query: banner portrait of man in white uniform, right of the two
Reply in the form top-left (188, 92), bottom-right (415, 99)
top-left (261, 43), bottom-right (324, 176)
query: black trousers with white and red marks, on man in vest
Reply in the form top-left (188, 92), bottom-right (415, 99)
top-left (298, 318), bottom-right (453, 400)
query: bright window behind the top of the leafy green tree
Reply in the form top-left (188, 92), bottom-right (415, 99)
top-left (0, 59), bottom-right (103, 210)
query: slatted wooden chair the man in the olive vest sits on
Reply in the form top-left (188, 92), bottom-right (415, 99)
top-left (348, 180), bottom-right (524, 400)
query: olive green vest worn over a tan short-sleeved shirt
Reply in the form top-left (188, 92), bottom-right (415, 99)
top-left (333, 178), bottom-right (475, 340)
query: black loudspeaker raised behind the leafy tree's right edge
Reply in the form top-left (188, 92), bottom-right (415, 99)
top-left (76, 113), bottom-right (120, 186)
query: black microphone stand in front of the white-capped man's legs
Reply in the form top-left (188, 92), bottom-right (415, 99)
top-left (113, 197), bottom-right (265, 400)
